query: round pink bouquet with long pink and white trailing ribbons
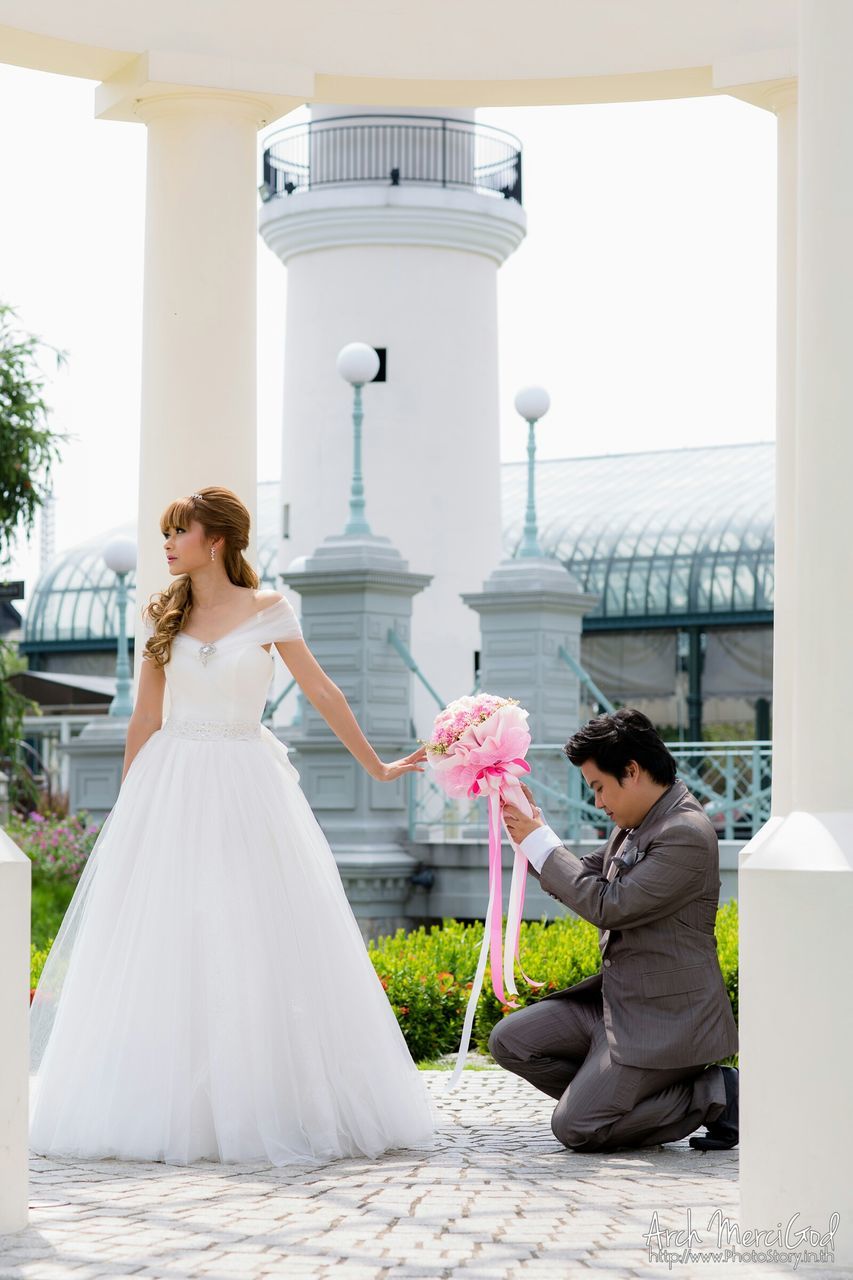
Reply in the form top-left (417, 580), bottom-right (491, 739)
top-left (424, 694), bottom-right (542, 1087)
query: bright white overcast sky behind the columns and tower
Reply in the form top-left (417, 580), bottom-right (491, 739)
top-left (0, 65), bottom-right (776, 612)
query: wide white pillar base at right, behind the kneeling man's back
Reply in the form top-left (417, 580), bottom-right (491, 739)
top-left (739, 812), bottom-right (853, 1267)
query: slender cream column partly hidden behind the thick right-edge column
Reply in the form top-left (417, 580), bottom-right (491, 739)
top-left (768, 81), bottom-right (797, 815)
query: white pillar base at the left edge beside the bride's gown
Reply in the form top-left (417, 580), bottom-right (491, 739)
top-left (0, 829), bottom-right (31, 1235)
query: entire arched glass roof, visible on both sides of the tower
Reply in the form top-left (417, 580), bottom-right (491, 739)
top-left (23, 443), bottom-right (774, 648)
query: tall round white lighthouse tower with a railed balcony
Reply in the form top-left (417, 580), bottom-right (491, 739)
top-left (260, 105), bottom-right (526, 736)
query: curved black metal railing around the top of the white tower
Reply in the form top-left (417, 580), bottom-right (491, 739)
top-left (261, 113), bottom-right (521, 204)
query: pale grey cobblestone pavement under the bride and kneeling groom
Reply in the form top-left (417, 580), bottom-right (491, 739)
top-left (0, 1069), bottom-right (835, 1280)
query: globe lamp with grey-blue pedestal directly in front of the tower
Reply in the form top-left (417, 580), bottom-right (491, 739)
top-left (282, 342), bottom-right (430, 937)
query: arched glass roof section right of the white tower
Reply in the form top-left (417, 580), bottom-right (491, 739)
top-left (501, 443), bottom-right (775, 618)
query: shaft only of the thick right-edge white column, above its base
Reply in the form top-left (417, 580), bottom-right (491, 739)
top-left (793, 0), bottom-right (853, 798)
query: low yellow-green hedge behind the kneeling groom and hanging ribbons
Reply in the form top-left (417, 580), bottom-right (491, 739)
top-left (368, 900), bottom-right (738, 1064)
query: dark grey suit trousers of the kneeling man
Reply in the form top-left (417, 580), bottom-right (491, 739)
top-left (489, 997), bottom-right (726, 1152)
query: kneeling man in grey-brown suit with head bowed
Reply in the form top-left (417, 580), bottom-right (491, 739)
top-left (489, 708), bottom-right (738, 1152)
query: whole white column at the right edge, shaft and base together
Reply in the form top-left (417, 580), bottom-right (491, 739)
top-left (740, 0), bottom-right (853, 1267)
